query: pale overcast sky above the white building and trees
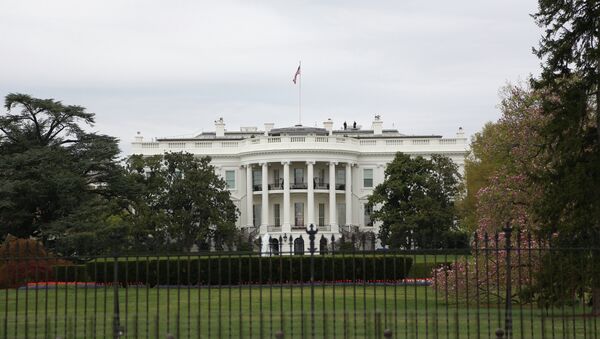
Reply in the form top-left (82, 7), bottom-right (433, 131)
top-left (0, 0), bottom-right (541, 153)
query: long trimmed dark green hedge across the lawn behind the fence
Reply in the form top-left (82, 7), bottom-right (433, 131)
top-left (86, 254), bottom-right (412, 286)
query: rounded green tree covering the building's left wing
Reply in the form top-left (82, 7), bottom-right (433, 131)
top-left (127, 153), bottom-right (238, 251)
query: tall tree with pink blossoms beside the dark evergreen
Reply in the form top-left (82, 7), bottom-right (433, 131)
top-left (433, 86), bottom-right (545, 302)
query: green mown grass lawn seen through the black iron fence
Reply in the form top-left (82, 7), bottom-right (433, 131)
top-left (0, 285), bottom-right (599, 338)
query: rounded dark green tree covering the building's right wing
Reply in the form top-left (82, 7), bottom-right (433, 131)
top-left (369, 153), bottom-right (461, 248)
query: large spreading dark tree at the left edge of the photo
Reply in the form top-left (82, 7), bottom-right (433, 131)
top-left (0, 94), bottom-right (125, 254)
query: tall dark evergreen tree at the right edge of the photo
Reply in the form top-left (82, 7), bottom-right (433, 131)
top-left (532, 0), bottom-right (600, 314)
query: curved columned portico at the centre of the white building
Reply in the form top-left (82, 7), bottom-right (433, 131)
top-left (244, 160), bottom-right (352, 234)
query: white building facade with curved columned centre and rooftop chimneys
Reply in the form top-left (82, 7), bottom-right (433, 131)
top-left (132, 116), bottom-right (468, 251)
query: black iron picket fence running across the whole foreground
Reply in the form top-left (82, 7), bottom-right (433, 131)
top-left (0, 229), bottom-right (600, 338)
